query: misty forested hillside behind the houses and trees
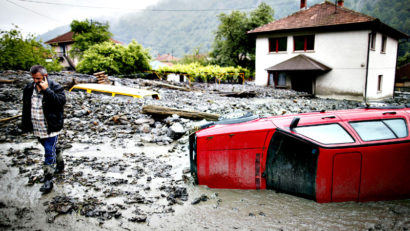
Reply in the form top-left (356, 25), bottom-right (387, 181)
top-left (37, 0), bottom-right (409, 57)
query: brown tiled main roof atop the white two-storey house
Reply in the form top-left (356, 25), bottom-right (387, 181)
top-left (248, 1), bottom-right (408, 38)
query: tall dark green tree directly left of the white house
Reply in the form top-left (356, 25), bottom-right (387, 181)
top-left (211, 3), bottom-right (274, 70)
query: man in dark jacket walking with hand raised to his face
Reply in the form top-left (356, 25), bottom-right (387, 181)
top-left (22, 65), bottom-right (66, 193)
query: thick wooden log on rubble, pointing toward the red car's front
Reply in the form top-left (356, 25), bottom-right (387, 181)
top-left (142, 105), bottom-right (219, 121)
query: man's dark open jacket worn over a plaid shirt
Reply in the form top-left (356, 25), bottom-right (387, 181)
top-left (22, 78), bottom-right (66, 134)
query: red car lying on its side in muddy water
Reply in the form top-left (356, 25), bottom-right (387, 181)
top-left (190, 107), bottom-right (410, 202)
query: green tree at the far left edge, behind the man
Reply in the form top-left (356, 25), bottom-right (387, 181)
top-left (0, 26), bottom-right (62, 71)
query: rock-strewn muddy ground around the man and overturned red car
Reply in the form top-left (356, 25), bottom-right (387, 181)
top-left (0, 71), bottom-right (410, 230)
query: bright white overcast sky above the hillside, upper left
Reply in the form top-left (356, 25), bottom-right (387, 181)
top-left (0, 0), bottom-right (161, 36)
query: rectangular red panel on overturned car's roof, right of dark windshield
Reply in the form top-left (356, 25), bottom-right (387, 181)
top-left (332, 152), bottom-right (362, 202)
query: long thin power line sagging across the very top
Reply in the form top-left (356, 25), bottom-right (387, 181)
top-left (13, 0), bottom-right (254, 12)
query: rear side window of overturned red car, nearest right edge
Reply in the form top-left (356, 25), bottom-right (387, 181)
top-left (350, 119), bottom-right (408, 141)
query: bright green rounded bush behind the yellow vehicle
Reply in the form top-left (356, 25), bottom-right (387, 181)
top-left (77, 40), bottom-right (151, 74)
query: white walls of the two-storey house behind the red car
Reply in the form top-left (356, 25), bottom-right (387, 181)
top-left (255, 30), bottom-right (397, 100)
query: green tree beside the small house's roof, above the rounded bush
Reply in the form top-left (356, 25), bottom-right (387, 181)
top-left (70, 19), bottom-right (112, 58)
